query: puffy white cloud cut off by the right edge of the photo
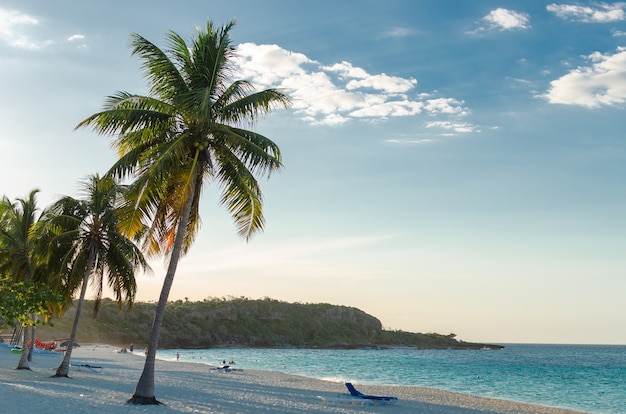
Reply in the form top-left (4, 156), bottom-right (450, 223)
top-left (543, 48), bottom-right (626, 108)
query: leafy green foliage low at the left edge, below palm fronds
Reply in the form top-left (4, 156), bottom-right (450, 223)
top-left (0, 276), bottom-right (63, 326)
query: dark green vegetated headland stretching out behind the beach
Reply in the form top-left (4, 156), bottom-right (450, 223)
top-left (31, 298), bottom-right (499, 349)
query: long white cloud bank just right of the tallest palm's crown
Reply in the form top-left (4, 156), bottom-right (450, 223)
top-left (236, 43), bottom-right (469, 125)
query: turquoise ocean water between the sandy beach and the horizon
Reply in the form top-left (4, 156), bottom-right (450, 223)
top-left (157, 344), bottom-right (626, 414)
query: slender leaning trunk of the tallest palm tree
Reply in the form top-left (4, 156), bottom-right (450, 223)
top-left (126, 187), bottom-right (193, 405)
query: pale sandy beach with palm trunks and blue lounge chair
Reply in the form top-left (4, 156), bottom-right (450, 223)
top-left (0, 345), bottom-right (574, 414)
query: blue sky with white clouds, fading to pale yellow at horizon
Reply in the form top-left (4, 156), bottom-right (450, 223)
top-left (0, 0), bottom-right (626, 344)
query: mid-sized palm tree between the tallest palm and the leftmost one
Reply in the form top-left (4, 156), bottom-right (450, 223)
top-left (46, 175), bottom-right (148, 377)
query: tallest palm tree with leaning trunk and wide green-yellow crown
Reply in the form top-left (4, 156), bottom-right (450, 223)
top-left (77, 21), bottom-right (289, 404)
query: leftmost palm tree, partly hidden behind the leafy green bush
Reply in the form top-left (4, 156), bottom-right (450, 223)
top-left (0, 189), bottom-right (50, 369)
